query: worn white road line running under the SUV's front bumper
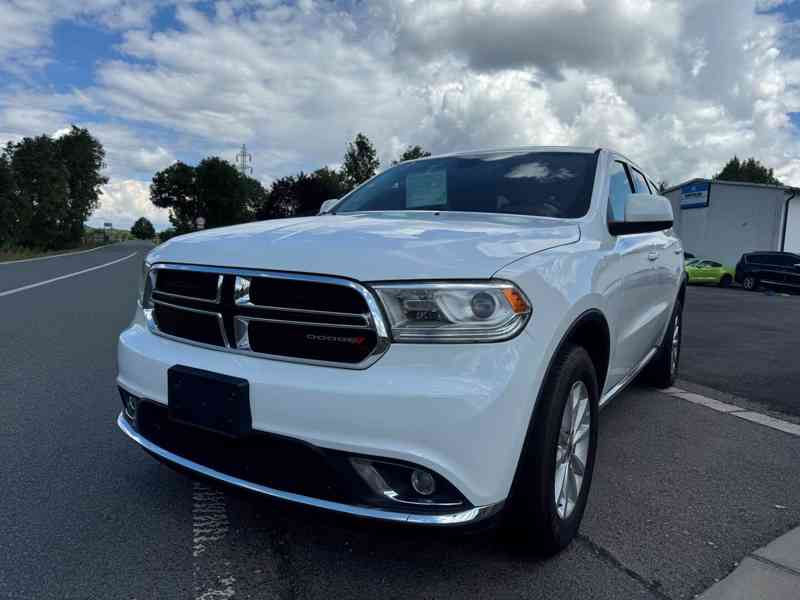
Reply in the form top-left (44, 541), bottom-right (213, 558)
top-left (192, 482), bottom-right (236, 600)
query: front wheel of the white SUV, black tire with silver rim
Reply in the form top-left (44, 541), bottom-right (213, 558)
top-left (503, 344), bottom-right (599, 556)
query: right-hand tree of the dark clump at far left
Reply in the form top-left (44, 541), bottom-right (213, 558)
top-left (55, 125), bottom-right (108, 243)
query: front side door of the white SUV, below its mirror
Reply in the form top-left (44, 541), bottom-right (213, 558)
top-left (606, 159), bottom-right (668, 388)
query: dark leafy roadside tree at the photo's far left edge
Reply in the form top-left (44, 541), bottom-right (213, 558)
top-left (11, 135), bottom-right (72, 249)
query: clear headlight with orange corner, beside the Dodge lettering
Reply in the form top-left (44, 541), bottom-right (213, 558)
top-left (373, 281), bottom-right (531, 342)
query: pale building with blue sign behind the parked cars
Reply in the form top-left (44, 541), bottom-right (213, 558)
top-left (664, 179), bottom-right (800, 266)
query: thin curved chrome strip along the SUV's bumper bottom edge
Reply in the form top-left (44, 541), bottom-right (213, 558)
top-left (117, 413), bottom-right (503, 526)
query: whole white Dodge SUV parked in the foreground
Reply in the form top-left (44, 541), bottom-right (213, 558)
top-left (117, 148), bottom-right (685, 554)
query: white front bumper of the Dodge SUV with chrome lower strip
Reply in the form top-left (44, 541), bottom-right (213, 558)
top-left (117, 304), bottom-right (546, 524)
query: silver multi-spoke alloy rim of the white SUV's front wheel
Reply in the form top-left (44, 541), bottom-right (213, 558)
top-left (553, 381), bottom-right (592, 519)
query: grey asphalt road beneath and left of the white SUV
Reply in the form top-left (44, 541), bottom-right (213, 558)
top-left (0, 244), bottom-right (800, 600)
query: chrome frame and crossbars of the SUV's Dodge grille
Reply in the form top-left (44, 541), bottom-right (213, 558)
top-left (141, 263), bottom-right (391, 369)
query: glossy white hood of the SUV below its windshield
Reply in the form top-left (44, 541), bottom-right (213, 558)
top-left (149, 212), bottom-right (580, 281)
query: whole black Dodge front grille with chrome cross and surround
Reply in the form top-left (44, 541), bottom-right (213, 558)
top-left (144, 264), bottom-right (388, 368)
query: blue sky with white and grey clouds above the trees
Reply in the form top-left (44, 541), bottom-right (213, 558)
top-left (0, 0), bottom-right (800, 229)
